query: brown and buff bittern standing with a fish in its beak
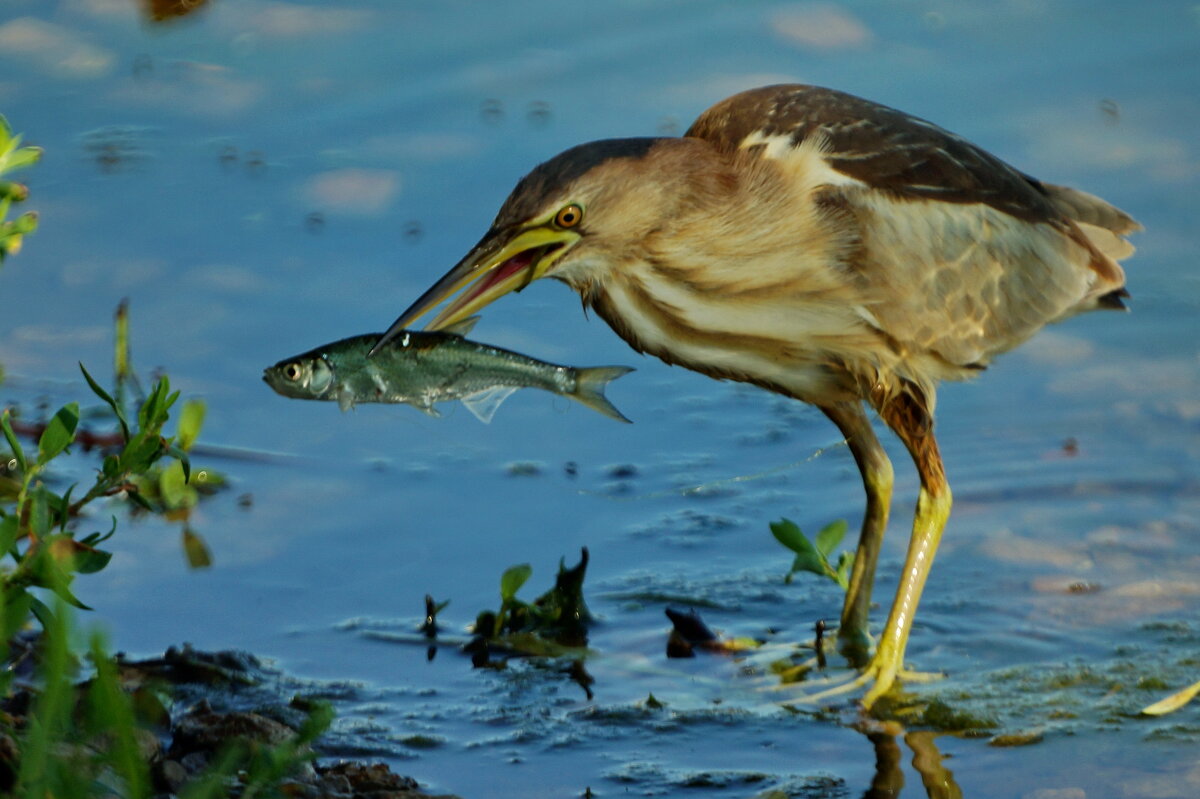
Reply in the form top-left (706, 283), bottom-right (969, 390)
top-left (377, 85), bottom-right (1140, 707)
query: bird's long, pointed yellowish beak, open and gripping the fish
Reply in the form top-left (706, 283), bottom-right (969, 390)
top-left (371, 224), bottom-right (580, 354)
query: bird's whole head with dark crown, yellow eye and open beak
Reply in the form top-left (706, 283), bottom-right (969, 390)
top-left (372, 138), bottom-right (709, 352)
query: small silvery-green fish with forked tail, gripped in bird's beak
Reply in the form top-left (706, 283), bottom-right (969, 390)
top-left (263, 317), bottom-right (634, 423)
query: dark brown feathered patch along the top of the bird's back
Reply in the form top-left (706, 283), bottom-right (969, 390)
top-left (684, 85), bottom-right (1063, 222)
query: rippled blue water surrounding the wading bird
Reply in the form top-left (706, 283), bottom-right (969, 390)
top-left (0, 0), bottom-right (1200, 799)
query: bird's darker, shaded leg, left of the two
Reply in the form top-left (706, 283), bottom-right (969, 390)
top-left (821, 402), bottom-right (893, 667)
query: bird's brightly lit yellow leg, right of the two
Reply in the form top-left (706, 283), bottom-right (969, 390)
top-left (863, 394), bottom-right (950, 708)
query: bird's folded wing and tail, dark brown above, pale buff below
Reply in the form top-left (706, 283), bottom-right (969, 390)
top-left (685, 85), bottom-right (1140, 388)
